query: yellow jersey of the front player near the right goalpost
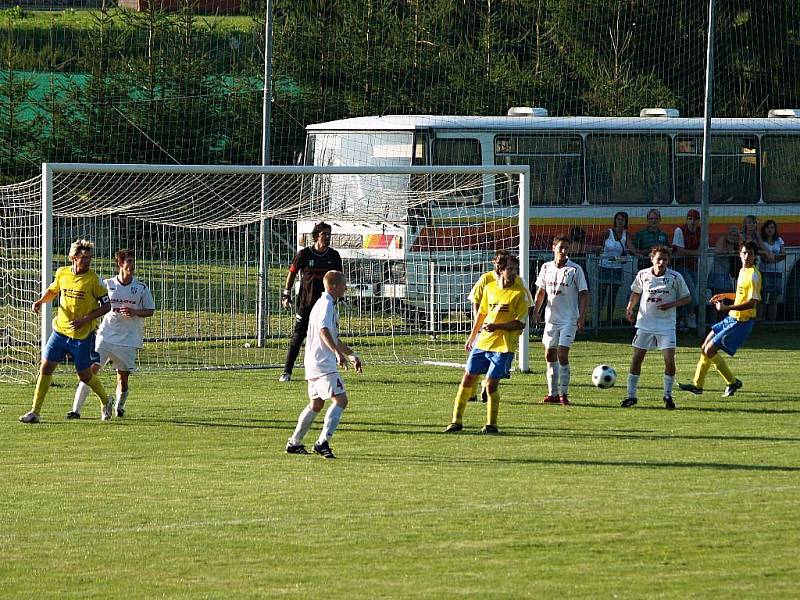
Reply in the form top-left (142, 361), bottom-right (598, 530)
top-left (475, 276), bottom-right (531, 352)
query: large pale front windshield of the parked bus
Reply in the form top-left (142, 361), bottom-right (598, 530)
top-left (306, 131), bottom-right (414, 221)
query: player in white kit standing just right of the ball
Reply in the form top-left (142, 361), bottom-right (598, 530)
top-left (622, 246), bottom-right (692, 410)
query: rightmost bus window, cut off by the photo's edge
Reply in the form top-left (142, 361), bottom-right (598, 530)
top-left (761, 135), bottom-right (800, 204)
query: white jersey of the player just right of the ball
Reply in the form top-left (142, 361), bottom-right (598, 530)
top-left (631, 267), bottom-right (690, 333)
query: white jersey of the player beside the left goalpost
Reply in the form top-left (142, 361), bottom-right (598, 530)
top-left (97, 277), bottom-right (156, 348)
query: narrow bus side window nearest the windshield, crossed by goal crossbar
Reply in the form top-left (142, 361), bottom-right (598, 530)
top-left (430, 138), bottom-right (483, 205)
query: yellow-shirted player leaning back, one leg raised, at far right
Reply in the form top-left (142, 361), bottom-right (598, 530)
top-left (678, 242), bottom-right (761, 398)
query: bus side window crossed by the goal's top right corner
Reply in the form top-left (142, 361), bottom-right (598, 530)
top-left (494, 135), bottom-right (583, 206)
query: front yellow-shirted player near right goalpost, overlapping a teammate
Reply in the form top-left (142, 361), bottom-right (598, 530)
top-left (445, 254), bottom-right (531, 433)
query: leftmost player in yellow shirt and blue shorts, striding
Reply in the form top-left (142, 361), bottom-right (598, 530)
top-left (19, 240), bottom-right (114, 423)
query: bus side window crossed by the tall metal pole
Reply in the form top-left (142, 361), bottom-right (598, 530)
top-left (675, 135), bottom-right (759, 204)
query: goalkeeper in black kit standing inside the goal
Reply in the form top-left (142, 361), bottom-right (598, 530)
top-left (278, 222), bottom-right (343, 383)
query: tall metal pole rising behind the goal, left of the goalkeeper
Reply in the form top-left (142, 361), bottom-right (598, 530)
top-left (256, 0), bottom-right (272, 348)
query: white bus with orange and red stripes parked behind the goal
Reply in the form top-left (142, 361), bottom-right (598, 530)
top-left (298, 107), bottom-right (800, 318)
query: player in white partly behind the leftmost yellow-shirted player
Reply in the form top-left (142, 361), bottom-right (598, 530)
top-left (67, 248), bottom-right (156, 419)
